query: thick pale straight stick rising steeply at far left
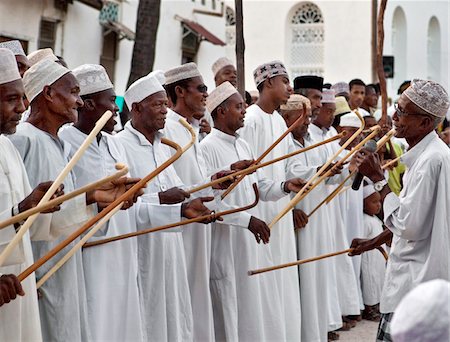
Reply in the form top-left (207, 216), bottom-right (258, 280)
top-left (0, 111), bottom-right (112, 266)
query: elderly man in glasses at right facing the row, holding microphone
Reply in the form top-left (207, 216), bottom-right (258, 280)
top-left (352, 79), bottom-right (450, 341)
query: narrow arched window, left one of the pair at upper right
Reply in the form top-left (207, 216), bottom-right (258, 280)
top-left (392, 6), bottom-right (408, 89)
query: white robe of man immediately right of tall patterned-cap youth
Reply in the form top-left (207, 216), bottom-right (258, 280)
top-left (289, 136), bottom-right (342, 342)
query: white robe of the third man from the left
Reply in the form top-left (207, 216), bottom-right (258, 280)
top-left (58, 126), bottom-right (145, 341)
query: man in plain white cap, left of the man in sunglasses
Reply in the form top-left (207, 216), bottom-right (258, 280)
top-left (114, 72), bottom-right (218, 341)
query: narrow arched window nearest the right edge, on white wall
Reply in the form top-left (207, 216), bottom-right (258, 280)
top-left (427, 17), bottom-right (441, 82)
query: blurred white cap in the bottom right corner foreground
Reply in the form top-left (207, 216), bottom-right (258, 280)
top-left (391, 279), bottom-right (450, 342)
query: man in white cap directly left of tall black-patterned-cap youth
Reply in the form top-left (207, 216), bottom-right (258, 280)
top-left (200, 82), bottom-right (304, 341)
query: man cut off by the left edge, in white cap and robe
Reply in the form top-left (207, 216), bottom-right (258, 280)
top-left (0, 49), bottom-right (62, 341)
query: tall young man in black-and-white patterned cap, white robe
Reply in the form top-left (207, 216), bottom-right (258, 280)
top-left (238, 61), bottom-right (301, 341)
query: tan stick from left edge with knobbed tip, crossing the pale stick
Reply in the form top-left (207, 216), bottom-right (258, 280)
top-left (0, 163), bottom-right (128, 229)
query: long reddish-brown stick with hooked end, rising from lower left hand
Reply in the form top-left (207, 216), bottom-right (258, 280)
top-left (18, 119), bottom-right (196, 281)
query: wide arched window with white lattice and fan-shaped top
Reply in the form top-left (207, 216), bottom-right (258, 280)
top-left (287, 2), bottom-right (324, 78)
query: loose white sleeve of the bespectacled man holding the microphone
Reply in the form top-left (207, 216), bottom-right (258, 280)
top-left (383, 160), bottom-right (438, 241)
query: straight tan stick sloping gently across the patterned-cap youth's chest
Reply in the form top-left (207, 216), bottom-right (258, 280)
top-left (188, 132), bottom-right (347, 194)
